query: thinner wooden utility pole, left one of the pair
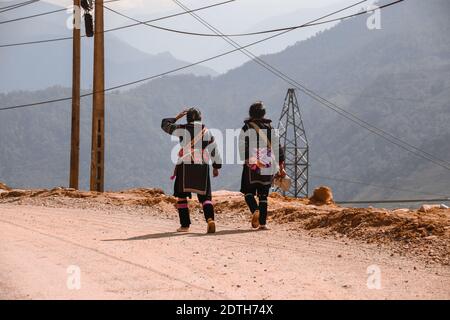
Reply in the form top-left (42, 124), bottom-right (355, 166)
top-left (69, 0), bottom-right (81, 189)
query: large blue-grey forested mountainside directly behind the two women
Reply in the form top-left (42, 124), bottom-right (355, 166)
top-left (0, 0), bottom-right (450, 200)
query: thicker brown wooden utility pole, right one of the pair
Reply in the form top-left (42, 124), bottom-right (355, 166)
top-left (91, 0), bottom-right (105, 192)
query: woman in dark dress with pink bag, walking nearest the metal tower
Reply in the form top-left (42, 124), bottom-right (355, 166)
top-left (239, 102), bottom-right (286, 230)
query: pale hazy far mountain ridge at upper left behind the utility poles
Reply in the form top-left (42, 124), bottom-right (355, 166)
top-left (0, 3), bottom-right (217, 92)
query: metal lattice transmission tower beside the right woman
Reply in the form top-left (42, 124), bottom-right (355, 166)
top-left (278, 89), bottom-right (309, 198)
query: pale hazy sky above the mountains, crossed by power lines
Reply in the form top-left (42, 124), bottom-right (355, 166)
top-left (38, 0), bottom-right (372, 72)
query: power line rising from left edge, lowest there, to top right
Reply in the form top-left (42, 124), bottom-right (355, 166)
top-left (0, 0), bottom-right (372, 111)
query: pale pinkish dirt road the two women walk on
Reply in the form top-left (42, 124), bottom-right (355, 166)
top-left (0, 204), bottom-right (450, 299)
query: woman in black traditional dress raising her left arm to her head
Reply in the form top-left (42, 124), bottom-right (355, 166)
top-left (161, 108), bottom-right (222, 233)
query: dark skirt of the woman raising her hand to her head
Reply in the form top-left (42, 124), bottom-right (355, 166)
top-left (173, 164), bottom-right (211, 198)
